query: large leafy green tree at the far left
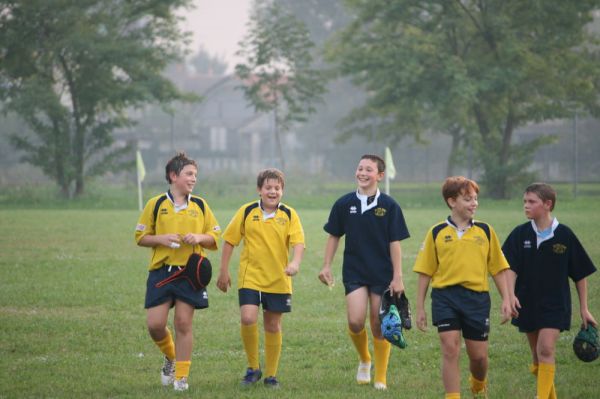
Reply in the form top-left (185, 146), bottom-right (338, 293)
top-left (0, 0), bottom-right (189, 197)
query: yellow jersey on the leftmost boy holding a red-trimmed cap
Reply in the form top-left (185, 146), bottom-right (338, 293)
top-left (135, 192), bottom-right (221, 270)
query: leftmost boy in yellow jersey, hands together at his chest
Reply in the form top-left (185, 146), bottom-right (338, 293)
top-left (135, 153), bottom-right (220, 391)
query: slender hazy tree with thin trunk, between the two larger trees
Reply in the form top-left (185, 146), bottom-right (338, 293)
top-left (235, 1), bottom-right (325, 169)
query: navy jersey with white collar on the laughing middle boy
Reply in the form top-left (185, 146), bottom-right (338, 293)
top-left (323, 192), bottom-right (410, 285)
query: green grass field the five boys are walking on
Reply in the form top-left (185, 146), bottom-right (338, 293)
top-left (0, 188), bottom-right (600, 398)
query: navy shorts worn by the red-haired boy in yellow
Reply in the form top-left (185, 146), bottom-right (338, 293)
top-left (431, 285), bottom-right (491, 341)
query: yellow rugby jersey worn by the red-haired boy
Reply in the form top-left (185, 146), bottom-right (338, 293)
top-left (413, 222), bottom-right (509, 292)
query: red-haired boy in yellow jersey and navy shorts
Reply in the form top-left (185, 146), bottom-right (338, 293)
top-left (413, 176), bottom-right (511, 399)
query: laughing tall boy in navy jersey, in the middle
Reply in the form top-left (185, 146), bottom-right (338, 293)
top-left (319, 155), bottom-right (409, 390)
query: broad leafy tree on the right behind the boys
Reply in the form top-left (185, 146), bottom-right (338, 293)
top-left (328, 0), bottom-right (600, 198)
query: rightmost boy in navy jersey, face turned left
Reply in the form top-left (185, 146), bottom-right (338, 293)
top-left (502, 183), bottom-right (597, 399)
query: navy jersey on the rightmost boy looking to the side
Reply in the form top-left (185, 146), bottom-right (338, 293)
top-left (502, 222), bottom-right (596, 332)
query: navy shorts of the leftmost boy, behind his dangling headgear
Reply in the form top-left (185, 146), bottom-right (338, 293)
top-left (144, 266), bottom-right (208, 309)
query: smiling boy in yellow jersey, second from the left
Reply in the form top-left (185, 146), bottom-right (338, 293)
top-left (217, 169), bottom-right (304, 388)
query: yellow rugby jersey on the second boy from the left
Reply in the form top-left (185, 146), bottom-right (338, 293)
top-left (223, 201), bottom-right (304, 294)
